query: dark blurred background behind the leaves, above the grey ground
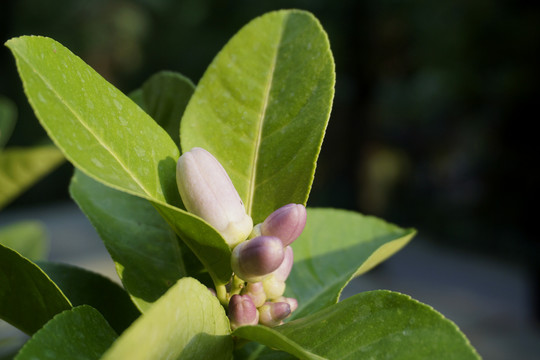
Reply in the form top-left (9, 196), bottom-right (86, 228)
top-left (0, 0), bottom-right (540, 358)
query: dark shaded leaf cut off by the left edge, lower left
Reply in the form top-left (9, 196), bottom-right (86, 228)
top-left (0, 245), bottom-right (71, 334)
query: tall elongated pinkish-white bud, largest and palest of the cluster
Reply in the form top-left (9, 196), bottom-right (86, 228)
top-left (176, 148), bottom-right (253, 248)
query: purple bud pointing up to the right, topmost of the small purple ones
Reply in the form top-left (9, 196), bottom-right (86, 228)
top-left (261, 204), bottom-right (307, 247)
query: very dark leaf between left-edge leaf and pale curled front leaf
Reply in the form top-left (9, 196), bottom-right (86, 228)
top-left (38, 262), bottom-right (140, 334)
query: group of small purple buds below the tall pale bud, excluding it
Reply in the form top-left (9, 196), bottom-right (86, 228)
top-left (229, 204), bottom-right (306, 329)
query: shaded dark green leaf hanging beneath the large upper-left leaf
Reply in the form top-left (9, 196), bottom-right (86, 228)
top-left (69, 170), bottom-right (187, 311)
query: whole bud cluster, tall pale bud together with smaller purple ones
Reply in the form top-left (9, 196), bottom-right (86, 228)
top-left (176, 148), bottom-right (306, 329)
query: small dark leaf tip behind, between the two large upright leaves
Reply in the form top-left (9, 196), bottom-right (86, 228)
top-left (130, 71), bottom-right (195, 147)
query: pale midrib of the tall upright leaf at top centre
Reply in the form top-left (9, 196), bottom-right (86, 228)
top-left (246, 26), bottom-right (283, 216)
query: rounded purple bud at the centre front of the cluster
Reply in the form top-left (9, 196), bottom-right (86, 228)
top-left (231, 236), bottom-right (285, 282)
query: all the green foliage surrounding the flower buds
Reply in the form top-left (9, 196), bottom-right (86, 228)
top-left (0, 10), bottom-right (478, 359)
